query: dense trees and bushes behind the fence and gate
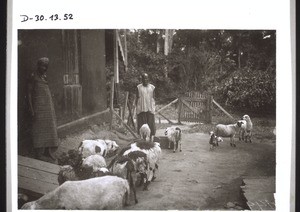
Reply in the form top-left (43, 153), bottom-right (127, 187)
top-left (121, 29), bottom-right (276, 113)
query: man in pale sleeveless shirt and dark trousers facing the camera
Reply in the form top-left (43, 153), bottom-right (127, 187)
top-left (136, 73), bottom-right (156, 141)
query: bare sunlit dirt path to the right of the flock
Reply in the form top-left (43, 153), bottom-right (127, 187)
top-left (124, 126), bottom-right (275, 210)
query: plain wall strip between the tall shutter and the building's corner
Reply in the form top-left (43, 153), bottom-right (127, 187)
top-left (80, 30), bottom-right (107, 111)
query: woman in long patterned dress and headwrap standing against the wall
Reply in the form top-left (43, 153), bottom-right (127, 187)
top-left (28, 57), bottom-right (58, 160)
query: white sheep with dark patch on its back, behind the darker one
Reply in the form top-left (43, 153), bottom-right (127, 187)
top-left (123, 141), bottom-right (161, 187)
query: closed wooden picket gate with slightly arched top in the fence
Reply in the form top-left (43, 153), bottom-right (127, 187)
top-left (178, 91), bottom-right (212, 123)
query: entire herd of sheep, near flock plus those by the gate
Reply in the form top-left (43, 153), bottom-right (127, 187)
top-left (22, 115), bottom-right (253, 210)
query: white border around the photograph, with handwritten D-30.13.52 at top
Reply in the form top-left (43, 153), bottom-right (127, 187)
top-left (6, 0), bottom-right (294, 211)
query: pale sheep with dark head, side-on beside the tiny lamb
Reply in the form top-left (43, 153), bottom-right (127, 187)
top-left (215, 122), bottom-right (242, 147)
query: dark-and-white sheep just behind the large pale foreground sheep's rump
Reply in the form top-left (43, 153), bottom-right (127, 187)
top-left (108, 151), bottom-right (148, 203)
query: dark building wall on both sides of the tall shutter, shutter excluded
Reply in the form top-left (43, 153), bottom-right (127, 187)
top-left (16, 30), bottom-right (107, 151)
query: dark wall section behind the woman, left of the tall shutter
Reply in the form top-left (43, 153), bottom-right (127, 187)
top-left (16, 30), bottom-right (64, 149)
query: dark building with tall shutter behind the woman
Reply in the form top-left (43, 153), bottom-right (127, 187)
top-left (16, 29), bottom-right (127, 152)
